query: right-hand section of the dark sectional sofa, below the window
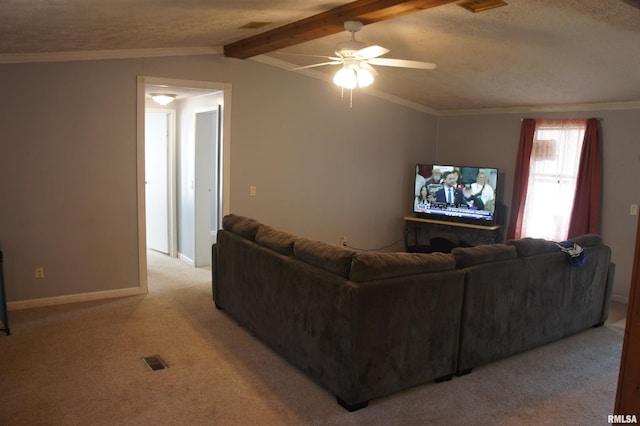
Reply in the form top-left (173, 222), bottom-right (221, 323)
top-left (452, 234), bottom-right (615, 375)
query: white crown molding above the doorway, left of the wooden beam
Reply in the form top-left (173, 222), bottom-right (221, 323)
top-left (0, 46), bottom-right (224, 64)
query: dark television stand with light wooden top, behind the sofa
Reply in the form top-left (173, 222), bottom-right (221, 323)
top-left (404, 216), bottom-right (502, 252)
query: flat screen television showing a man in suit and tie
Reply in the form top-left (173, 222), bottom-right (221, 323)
top-left (413, 164), bottom-right (498, 226)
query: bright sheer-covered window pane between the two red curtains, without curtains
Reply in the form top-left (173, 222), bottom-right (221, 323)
top-left (521, 120), bottom-right (586, 241)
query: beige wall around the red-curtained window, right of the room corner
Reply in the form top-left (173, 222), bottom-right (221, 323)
top-left (437, 109), bottom-right (640, 303)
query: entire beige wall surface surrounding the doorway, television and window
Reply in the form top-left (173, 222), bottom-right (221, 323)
top-left (0, 56), bottom-right (640, 303)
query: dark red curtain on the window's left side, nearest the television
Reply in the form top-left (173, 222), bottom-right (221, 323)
top-left (507, 118), bottom-right (536, 239)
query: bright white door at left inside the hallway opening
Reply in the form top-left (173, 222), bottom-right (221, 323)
top-left (144, 112), bottom-right (170, 254)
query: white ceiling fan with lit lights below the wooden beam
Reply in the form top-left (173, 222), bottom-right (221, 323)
top-left (278, 21), bottom-right (436, 89)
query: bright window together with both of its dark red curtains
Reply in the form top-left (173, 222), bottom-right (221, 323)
top-left (507, 118), bottom-right (602, 240)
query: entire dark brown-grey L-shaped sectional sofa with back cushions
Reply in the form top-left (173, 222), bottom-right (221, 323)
top-left (212, 215), bottom-right (613, 411)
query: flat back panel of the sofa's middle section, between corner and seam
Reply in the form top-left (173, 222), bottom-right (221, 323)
top-left (348, 270), bottom-right (464, 403)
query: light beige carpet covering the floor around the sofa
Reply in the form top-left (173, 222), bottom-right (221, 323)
top-left (0, 253), bottom-right (623, 426)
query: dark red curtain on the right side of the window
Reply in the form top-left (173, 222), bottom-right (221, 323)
top-left (569, 118), bottom-right (602, 238)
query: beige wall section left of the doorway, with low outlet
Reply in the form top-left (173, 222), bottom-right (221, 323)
top-left (0, 61), bottom-right (138, 302)
